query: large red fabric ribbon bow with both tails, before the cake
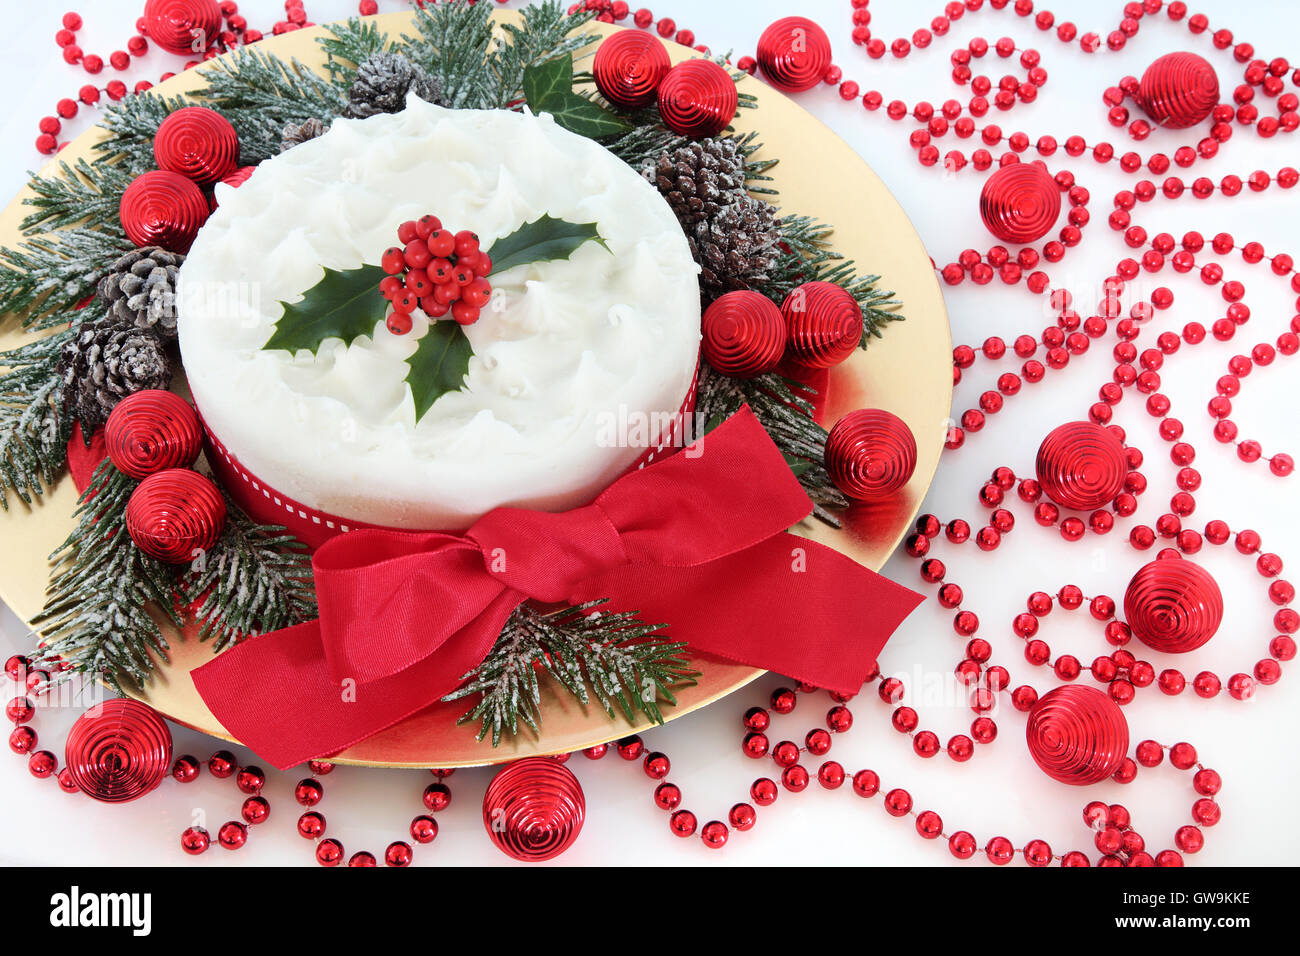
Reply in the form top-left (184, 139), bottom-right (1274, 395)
top-left (192, 408), bottom-right (922, 769)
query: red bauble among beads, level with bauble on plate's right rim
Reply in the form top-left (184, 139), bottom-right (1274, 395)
top-left (1035, 421), bottom-right (1128, 511)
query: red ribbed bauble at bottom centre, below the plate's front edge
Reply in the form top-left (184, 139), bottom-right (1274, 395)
top-left (484, 757), bottom-right (586, 862)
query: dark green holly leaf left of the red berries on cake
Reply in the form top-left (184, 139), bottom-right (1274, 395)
top-left (263, 265), bottom-right (387, 352)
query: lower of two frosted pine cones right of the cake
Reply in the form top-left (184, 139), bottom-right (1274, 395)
top-left (686, 195), bottom-right (781, 304)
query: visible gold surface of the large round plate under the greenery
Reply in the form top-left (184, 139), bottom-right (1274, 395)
top-left (0, 10), bottom-right (952, 767)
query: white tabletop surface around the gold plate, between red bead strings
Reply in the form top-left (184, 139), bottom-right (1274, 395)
top-left (0, 0), bottom-right (1300, 866)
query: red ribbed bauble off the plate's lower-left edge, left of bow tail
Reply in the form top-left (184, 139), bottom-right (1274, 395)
top-left (64, 697), bottom-right (172, 804)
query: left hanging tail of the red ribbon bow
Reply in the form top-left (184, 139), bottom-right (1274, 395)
top-left (190, 591), bottom-right (520, 770)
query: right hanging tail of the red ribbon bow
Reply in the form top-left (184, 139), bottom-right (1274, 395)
top-left (577, 532), bottom-right (924, 695)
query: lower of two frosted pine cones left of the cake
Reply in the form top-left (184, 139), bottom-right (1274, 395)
top-left (59, 321), bottom-right (172, 440)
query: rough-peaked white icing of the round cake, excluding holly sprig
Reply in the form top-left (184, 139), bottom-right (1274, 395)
top-left (178, 98), bottom-right (699, 529)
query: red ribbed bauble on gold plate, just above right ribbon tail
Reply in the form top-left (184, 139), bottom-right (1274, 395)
top-left (826, 408), bottom-right (917, 501)
